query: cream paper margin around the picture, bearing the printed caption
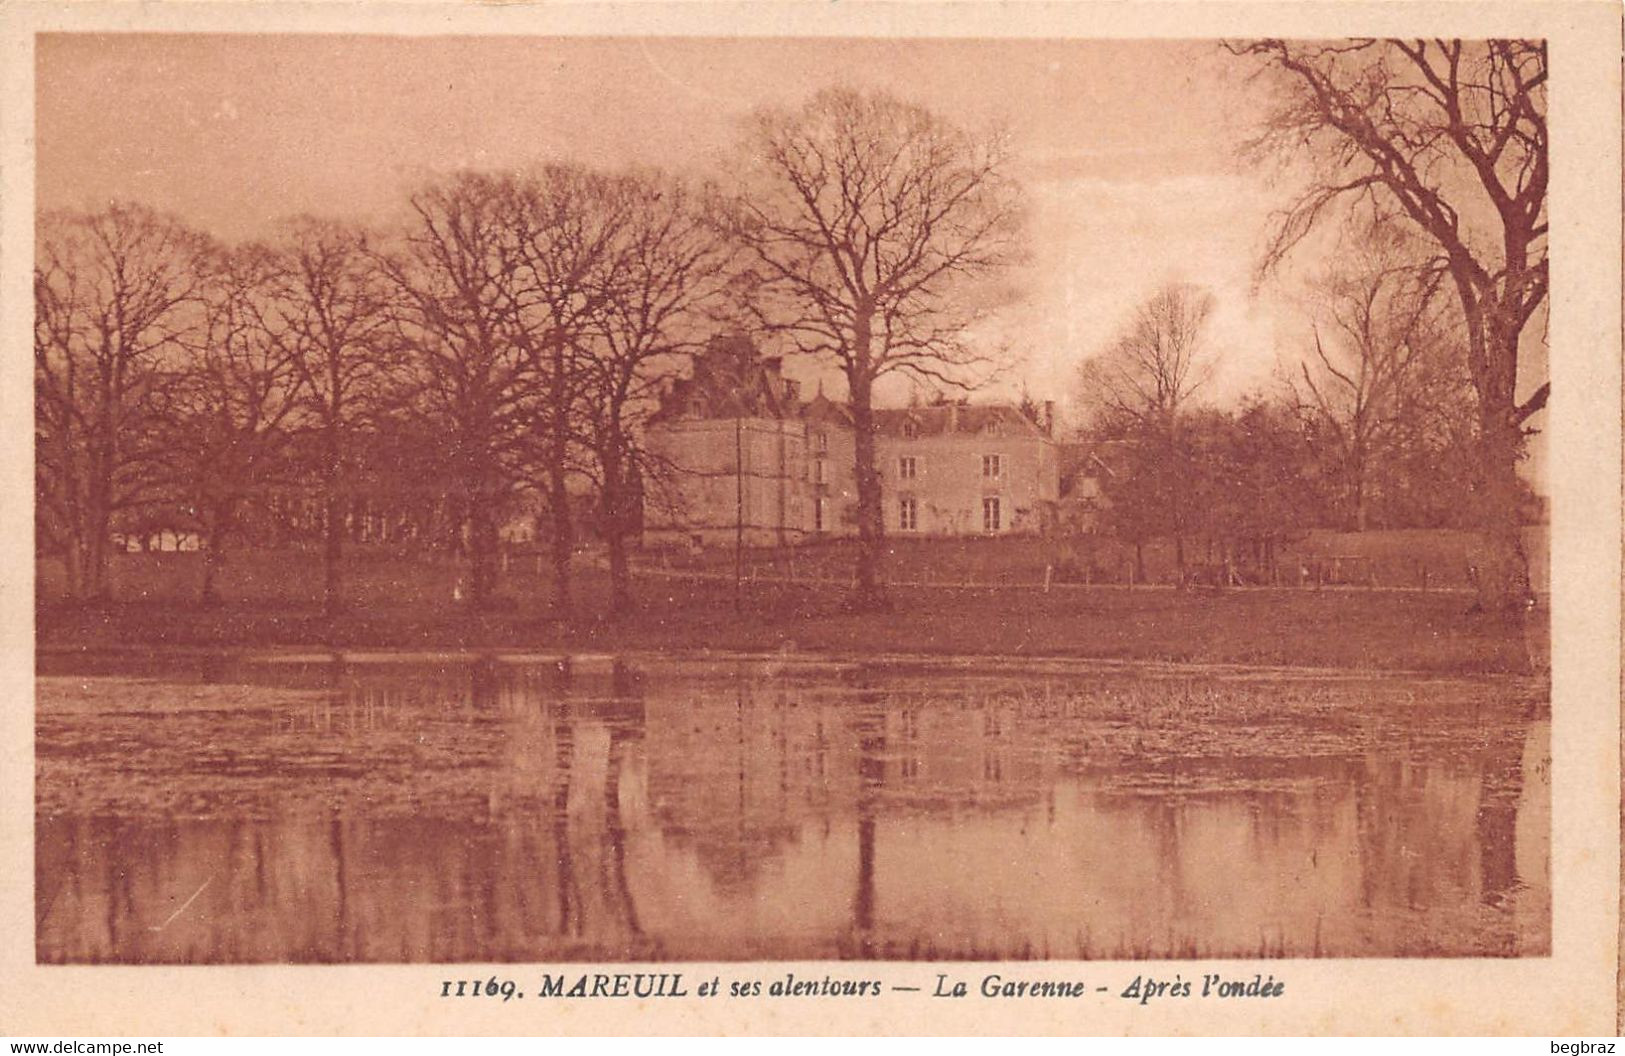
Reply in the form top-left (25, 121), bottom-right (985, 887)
top-left (0, 0), bottom-right (1622, 1037)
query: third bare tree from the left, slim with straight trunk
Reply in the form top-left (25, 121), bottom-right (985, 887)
top-left (260, 218), bottom-right (398, 616)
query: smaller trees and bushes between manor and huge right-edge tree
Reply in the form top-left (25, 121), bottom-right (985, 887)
top-left (1077, 224), bottom-right (1495, 584)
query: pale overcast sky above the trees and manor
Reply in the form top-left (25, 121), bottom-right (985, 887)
top-left (37, 34), bottom-right (1545, 490)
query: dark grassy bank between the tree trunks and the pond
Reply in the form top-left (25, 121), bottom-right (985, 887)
top-left (39, 554), bottom-right (1545, 673)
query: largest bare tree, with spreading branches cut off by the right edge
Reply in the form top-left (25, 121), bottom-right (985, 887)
top-left (1229, 41), bottom-right (1549, 611)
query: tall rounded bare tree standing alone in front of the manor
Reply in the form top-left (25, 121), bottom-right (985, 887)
top-left (728, 89), bottom-right (1022, 609)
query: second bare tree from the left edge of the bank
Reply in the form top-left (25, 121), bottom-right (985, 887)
top-left (159, 245), bottom-right (301, 604)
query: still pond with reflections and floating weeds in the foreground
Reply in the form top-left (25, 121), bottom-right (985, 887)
top-left (36, 655), bottom-right (1550, 963)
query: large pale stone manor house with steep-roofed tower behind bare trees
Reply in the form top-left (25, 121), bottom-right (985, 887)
top-left (644, 336), bottom-right (1061, 546)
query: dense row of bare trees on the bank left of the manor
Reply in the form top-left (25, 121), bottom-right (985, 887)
top-left (36, 166), bottom-right (728, 608)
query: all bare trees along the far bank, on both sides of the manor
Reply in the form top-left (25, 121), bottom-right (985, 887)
top-left (34, 41), bottom-right (1547, 608)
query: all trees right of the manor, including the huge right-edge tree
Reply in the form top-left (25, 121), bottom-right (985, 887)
top-left (1079, 39), bottom-right (1549, 611)
